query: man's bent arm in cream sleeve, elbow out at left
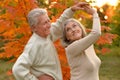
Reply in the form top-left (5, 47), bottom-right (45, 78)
top-left (12, 39), bottom-right (38, 80)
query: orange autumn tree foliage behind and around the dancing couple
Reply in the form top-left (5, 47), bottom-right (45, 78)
top-left (0, 0), bottom-right (120, 80)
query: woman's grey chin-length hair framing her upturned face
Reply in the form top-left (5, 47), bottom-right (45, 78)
top-left (61, 18), bottom-right (87, 47)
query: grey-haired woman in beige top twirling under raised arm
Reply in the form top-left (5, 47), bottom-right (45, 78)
top-left (63, 6), bottom-right (101, 80)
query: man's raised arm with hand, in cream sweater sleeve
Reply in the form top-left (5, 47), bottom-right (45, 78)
top-left (51, 2), bottom-right (88, 41)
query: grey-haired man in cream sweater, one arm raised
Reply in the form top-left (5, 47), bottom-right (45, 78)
top-left (12, 2), bottom-right (87, 80)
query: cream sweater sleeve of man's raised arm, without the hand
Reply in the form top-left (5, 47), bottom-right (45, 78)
top-left (51, 8), bottom-right (74, 41)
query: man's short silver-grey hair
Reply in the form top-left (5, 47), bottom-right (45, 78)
top-left (27, 8), bottom-right (47, 27)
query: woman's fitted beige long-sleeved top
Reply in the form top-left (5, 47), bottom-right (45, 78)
top-left (65, 13), bottom-right (101, 80)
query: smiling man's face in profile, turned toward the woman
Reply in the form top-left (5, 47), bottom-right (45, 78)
top-left (35, 14), bottom-right (51, 37)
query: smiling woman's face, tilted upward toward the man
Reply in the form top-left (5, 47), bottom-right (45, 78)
top-left (65, 21), bottom-right (82, 41)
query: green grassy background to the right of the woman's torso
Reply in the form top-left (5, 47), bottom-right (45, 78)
top-left (98, 47), bottom-right (120, 80)
